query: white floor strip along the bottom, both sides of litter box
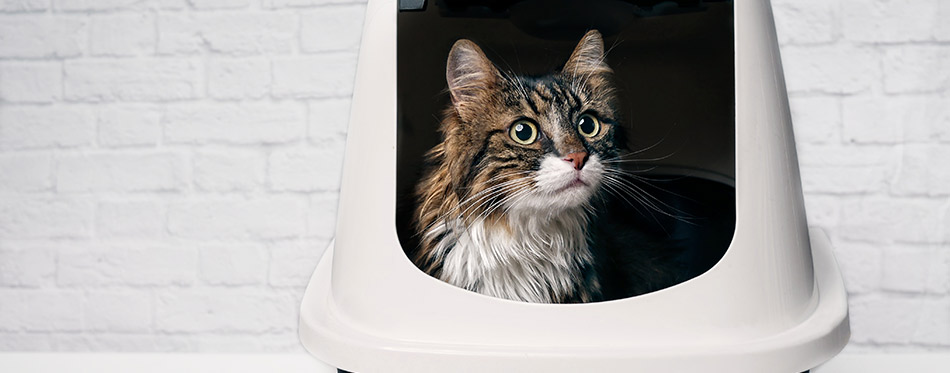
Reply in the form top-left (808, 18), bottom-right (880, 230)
top-left (0, 353), bottom-right (950, 373)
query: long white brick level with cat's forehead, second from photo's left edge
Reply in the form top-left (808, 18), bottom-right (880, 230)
top-left (65, 59), bottom-right (204, 101)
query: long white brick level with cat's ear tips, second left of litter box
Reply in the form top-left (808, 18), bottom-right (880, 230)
top-left (158, 12), bottom-right (298, 55)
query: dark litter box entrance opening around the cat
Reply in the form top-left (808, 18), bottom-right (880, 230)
top-left (395, 0), bottom-right (736, 300)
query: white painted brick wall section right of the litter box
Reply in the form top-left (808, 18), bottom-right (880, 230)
top-left (773, 0), bottom-right (950, 351)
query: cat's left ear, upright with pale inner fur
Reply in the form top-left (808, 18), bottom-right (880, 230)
top-left (445, 39), bottom-right (499, 119)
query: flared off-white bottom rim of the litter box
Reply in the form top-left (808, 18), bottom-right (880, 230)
top-left (299, 229), bottom-right (850, 373)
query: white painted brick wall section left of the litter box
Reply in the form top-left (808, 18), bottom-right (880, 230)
top-left (0, 0), bottom-right (354, 352)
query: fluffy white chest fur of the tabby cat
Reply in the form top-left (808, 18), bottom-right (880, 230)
top-left (436, 208), bottom-right (593, 303)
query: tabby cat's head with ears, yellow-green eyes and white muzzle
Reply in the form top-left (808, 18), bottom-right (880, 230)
top-left (442, 30), bottom-right (623, 216)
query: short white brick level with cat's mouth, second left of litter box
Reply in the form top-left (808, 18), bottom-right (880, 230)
top-left (195, 150), bottom-right (267, 192)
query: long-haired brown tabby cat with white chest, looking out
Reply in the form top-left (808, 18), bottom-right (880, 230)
top-left (413, 30), bottom-right (625, 303)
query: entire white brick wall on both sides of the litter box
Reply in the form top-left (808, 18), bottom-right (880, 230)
top-left (0, 0), bottom-right (950, 351)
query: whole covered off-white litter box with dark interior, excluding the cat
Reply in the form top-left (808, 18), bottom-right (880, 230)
top-left (299, 0), bottom-right (850, 373)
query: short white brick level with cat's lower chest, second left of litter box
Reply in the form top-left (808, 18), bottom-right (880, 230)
top-left (198, 245), bottom-right (269, 286)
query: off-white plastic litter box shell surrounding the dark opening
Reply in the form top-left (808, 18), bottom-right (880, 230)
top-left (299, 0), bottom-right (850, 373)
